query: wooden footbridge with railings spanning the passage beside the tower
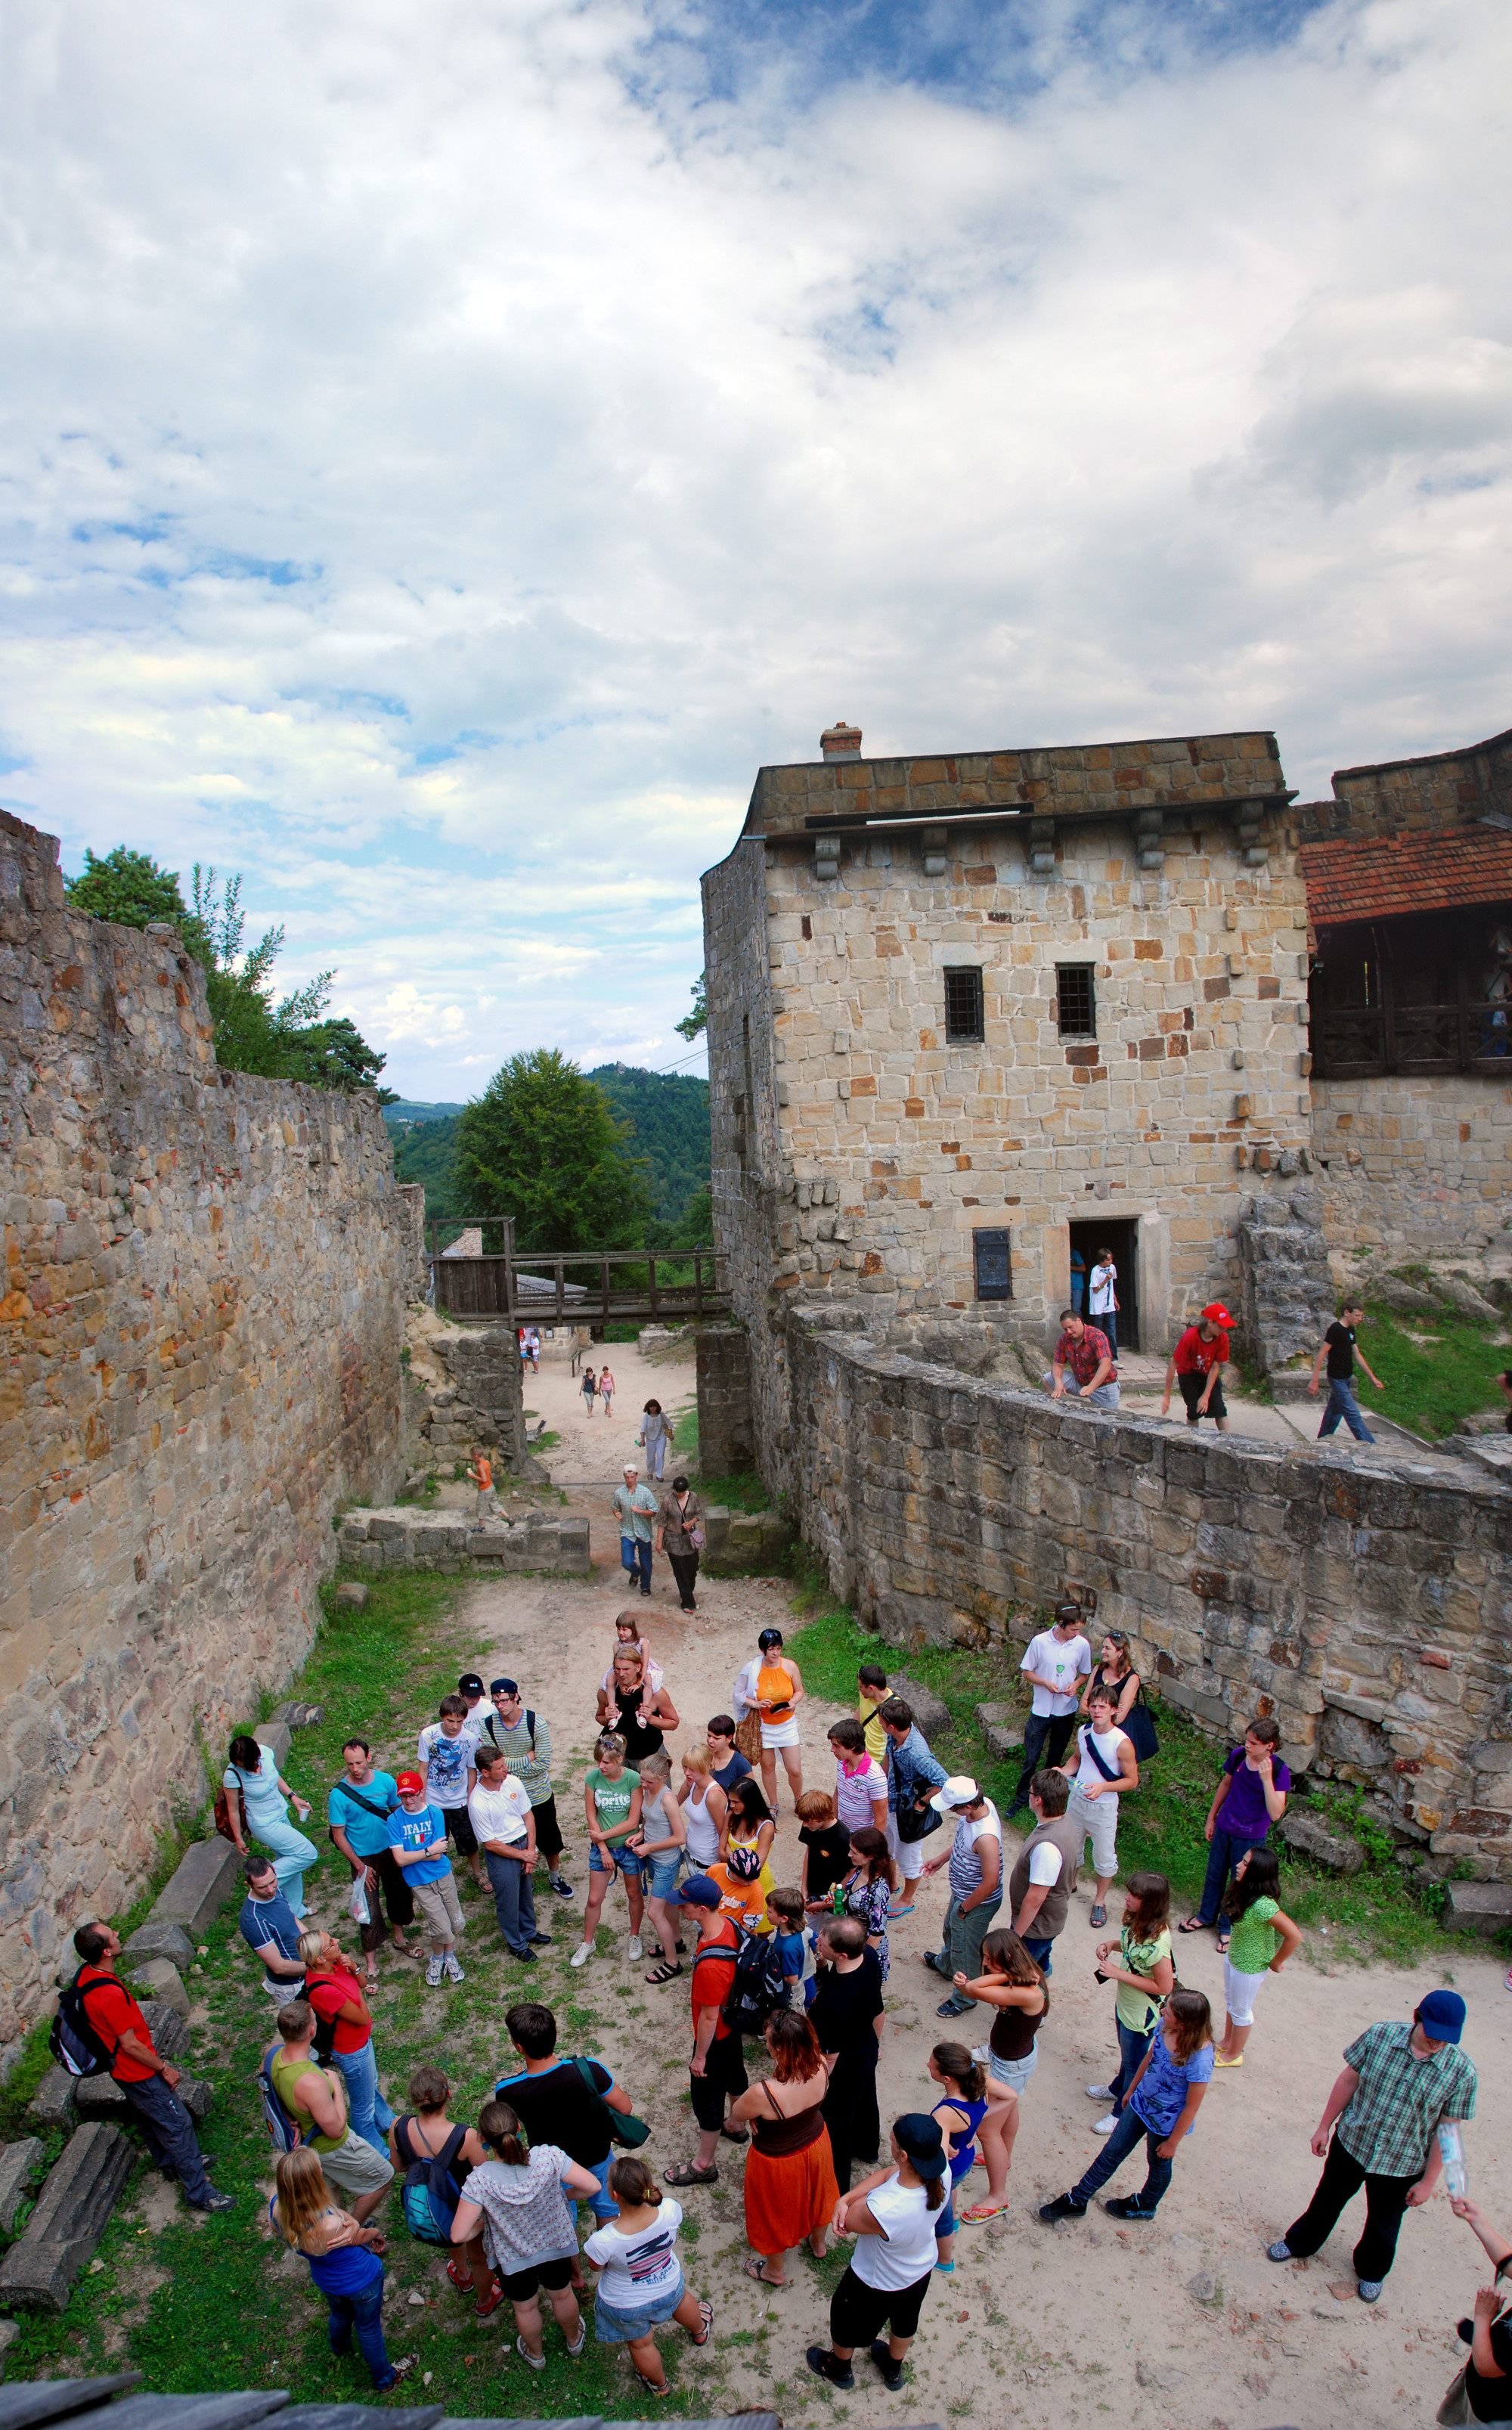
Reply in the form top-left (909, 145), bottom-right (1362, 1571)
top-left (430, 1215), bottom-right (730, 1325)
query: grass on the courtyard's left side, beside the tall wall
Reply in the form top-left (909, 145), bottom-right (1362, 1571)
top-left (5, 1572), bottom-right (727, 2420)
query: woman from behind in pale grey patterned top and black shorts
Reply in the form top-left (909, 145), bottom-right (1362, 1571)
top-left (452, 2100), bottom-right (598, 2372)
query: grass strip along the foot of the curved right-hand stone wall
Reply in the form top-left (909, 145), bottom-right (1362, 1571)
top-left (788, 1570), bottom-right (1454, 1966)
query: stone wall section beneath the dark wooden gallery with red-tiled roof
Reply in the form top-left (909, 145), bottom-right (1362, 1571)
top-left (1312, 1067), bottom-right (1512, 1257)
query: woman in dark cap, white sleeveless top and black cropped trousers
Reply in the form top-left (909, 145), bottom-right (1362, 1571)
top-left (807, 2109), bottom-right (948, 2388)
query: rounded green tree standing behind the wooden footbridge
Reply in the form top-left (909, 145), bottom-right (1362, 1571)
top-left (454, 1047), bottom-right (652, 1254)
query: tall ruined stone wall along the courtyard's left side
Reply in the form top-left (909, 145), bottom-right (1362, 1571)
top-left (0, 814), bottom-right (414, 2060)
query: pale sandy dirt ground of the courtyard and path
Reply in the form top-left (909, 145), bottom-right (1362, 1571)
top-left (442, 1347), bottom-right (1512, 2430)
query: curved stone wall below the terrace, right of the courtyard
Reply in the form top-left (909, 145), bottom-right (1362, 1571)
top-left (788, 1317), bottom-right (1512, 1881)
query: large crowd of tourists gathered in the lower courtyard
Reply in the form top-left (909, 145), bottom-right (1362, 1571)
top-left (66, 1594), bottom-right (1512, 2420)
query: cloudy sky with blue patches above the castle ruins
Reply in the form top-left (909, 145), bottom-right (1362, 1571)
top-left (0, 0), bottom-right (1512, 1099)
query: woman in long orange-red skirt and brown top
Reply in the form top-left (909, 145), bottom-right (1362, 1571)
top-left (730, 2007), bottom-right (841, 2286)
